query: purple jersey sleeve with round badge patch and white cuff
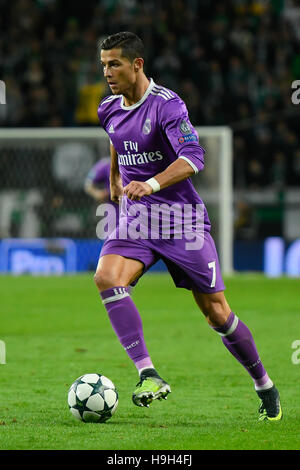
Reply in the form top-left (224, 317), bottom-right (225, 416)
top-left (161, 97), bottom-right (205, 173)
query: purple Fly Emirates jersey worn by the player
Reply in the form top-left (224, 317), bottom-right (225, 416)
top-left (98, 79), bottom-right (210, 237)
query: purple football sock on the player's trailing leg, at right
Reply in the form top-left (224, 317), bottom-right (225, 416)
top-left (213, 312), bottom-right (273, 390)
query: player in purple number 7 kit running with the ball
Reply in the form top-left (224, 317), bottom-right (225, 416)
top-left (95, 32), bottom-right (282, 421)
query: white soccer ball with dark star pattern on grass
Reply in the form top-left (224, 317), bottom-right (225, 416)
top-left (68, 374), bottom-right (118, 423)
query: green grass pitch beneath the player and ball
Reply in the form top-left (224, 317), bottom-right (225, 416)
top-left (0, 273), bottom-right (300, 450)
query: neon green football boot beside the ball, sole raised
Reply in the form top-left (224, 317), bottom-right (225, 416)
top-left (132, 369), bottom-right (171, 408)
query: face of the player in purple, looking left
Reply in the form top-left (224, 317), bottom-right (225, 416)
top-left (101, 49), bottom-right (136, 95)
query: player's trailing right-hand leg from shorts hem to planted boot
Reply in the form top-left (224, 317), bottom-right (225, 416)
top-left (193, 290), bottom-right (282, 421)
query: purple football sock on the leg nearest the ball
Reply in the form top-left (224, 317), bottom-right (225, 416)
top-left (100, 286), bottom-right (153, 371)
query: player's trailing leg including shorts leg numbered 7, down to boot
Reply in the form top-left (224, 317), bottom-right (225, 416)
top-left (152, 231), bottom-right (282, 421)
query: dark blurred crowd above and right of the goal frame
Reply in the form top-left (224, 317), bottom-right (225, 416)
top-left (0, 0), bottom-right (300, 189)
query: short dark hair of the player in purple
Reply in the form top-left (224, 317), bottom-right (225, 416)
top-left (99, 31), bottom-right (145, 62)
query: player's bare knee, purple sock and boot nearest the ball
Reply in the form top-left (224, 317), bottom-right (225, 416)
top-left (95, 254), bottom-right (171, 406)
